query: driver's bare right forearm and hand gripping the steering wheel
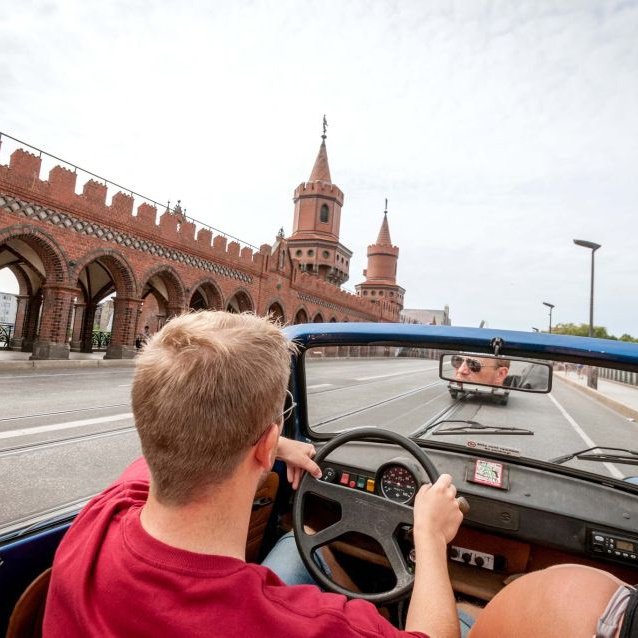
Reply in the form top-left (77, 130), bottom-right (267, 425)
top-left (406, 474), bottom-right (463, 638)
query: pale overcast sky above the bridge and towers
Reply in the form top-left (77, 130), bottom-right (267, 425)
top-left (0, 0), bottom-right (638, 336)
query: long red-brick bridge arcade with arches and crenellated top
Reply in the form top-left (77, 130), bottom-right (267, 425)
top-left (0, 134), bottom-right (404, 359)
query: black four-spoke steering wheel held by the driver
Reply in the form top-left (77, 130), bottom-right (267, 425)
top-left (292, 428), bottom-right (439, 605)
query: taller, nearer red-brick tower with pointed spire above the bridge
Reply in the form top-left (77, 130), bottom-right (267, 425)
top-left (288, 116), bottom-right (352, 286)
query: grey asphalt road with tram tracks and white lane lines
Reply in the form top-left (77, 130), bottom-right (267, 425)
top-left (0, 358), bottom-right (638, 528)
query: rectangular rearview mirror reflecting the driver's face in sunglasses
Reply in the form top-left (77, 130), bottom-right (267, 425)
top-left (439, 352), bottom-right (552, 392)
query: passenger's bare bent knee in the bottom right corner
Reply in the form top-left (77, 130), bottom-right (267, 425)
top-left (469, 565), bottom-right (624, 638)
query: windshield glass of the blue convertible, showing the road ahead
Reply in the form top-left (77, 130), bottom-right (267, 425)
top-left (305, 346), bottom-right (638, 479)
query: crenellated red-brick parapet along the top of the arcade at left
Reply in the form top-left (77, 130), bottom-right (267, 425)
top-left (0, 149), bottom-right (264, 274)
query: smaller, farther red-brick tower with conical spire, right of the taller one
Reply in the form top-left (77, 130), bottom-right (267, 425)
top-left (355, 199), bottom-right (405, 311)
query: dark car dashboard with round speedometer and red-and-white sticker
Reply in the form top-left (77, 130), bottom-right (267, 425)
top-left (321, 442), bottom-right (638, 600)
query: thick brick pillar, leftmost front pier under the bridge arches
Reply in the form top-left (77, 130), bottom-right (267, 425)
top-left (31, 285), bottom-right (78, 359)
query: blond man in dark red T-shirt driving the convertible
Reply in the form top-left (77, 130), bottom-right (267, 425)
top-left (43, 311), bottom-right (462, 638)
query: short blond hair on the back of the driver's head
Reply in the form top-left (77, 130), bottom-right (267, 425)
top-left (132, 311), bottom-right (294, 504)
